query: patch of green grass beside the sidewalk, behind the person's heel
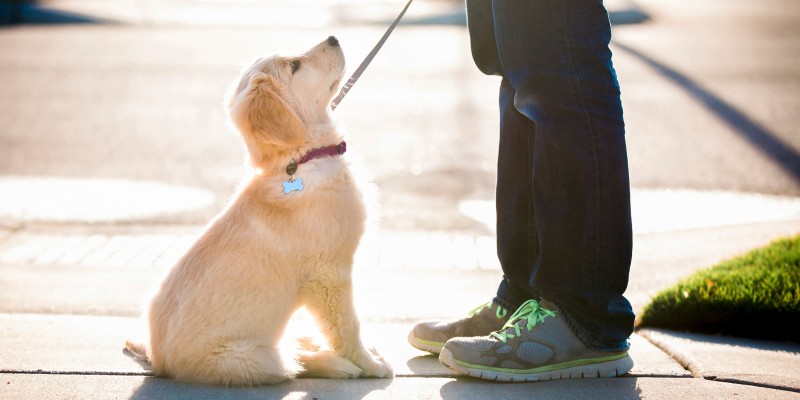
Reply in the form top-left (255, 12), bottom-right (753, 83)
top-left (639, 236), bottom-right (800, 342)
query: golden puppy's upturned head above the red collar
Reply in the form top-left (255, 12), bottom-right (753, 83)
top-left (226, 36), bottom-right (345, 163)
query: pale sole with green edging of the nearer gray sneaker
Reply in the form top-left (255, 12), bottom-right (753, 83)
top-left (439, 348), bottom-right (633, 382)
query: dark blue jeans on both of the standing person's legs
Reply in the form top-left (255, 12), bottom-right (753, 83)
top-left (467, 0), bottom-right (634, 350)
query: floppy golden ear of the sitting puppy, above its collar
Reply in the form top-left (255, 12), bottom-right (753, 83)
top-left (231, 72), bottom-right (306, 147)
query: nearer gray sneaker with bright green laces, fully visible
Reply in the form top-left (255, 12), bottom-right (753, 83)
top-left (439, 300), bottom-right (633, 382)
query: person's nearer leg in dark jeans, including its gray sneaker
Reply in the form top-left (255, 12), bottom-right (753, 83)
top-left (439, 0), bottom-right (634, 381)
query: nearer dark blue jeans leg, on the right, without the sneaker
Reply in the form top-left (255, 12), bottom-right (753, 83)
top-left (493, 0), bottom-right (634, 350)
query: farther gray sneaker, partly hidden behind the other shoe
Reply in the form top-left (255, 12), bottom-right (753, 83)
top-left (408, 301), bottom-right (509, 354)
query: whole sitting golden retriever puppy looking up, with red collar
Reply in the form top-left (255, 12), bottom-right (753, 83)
top-left (126, 37), bottom-right (393, 386)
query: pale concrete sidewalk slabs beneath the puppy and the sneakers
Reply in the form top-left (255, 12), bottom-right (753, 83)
top-left (0, 314), bottom-right (800, 399)
